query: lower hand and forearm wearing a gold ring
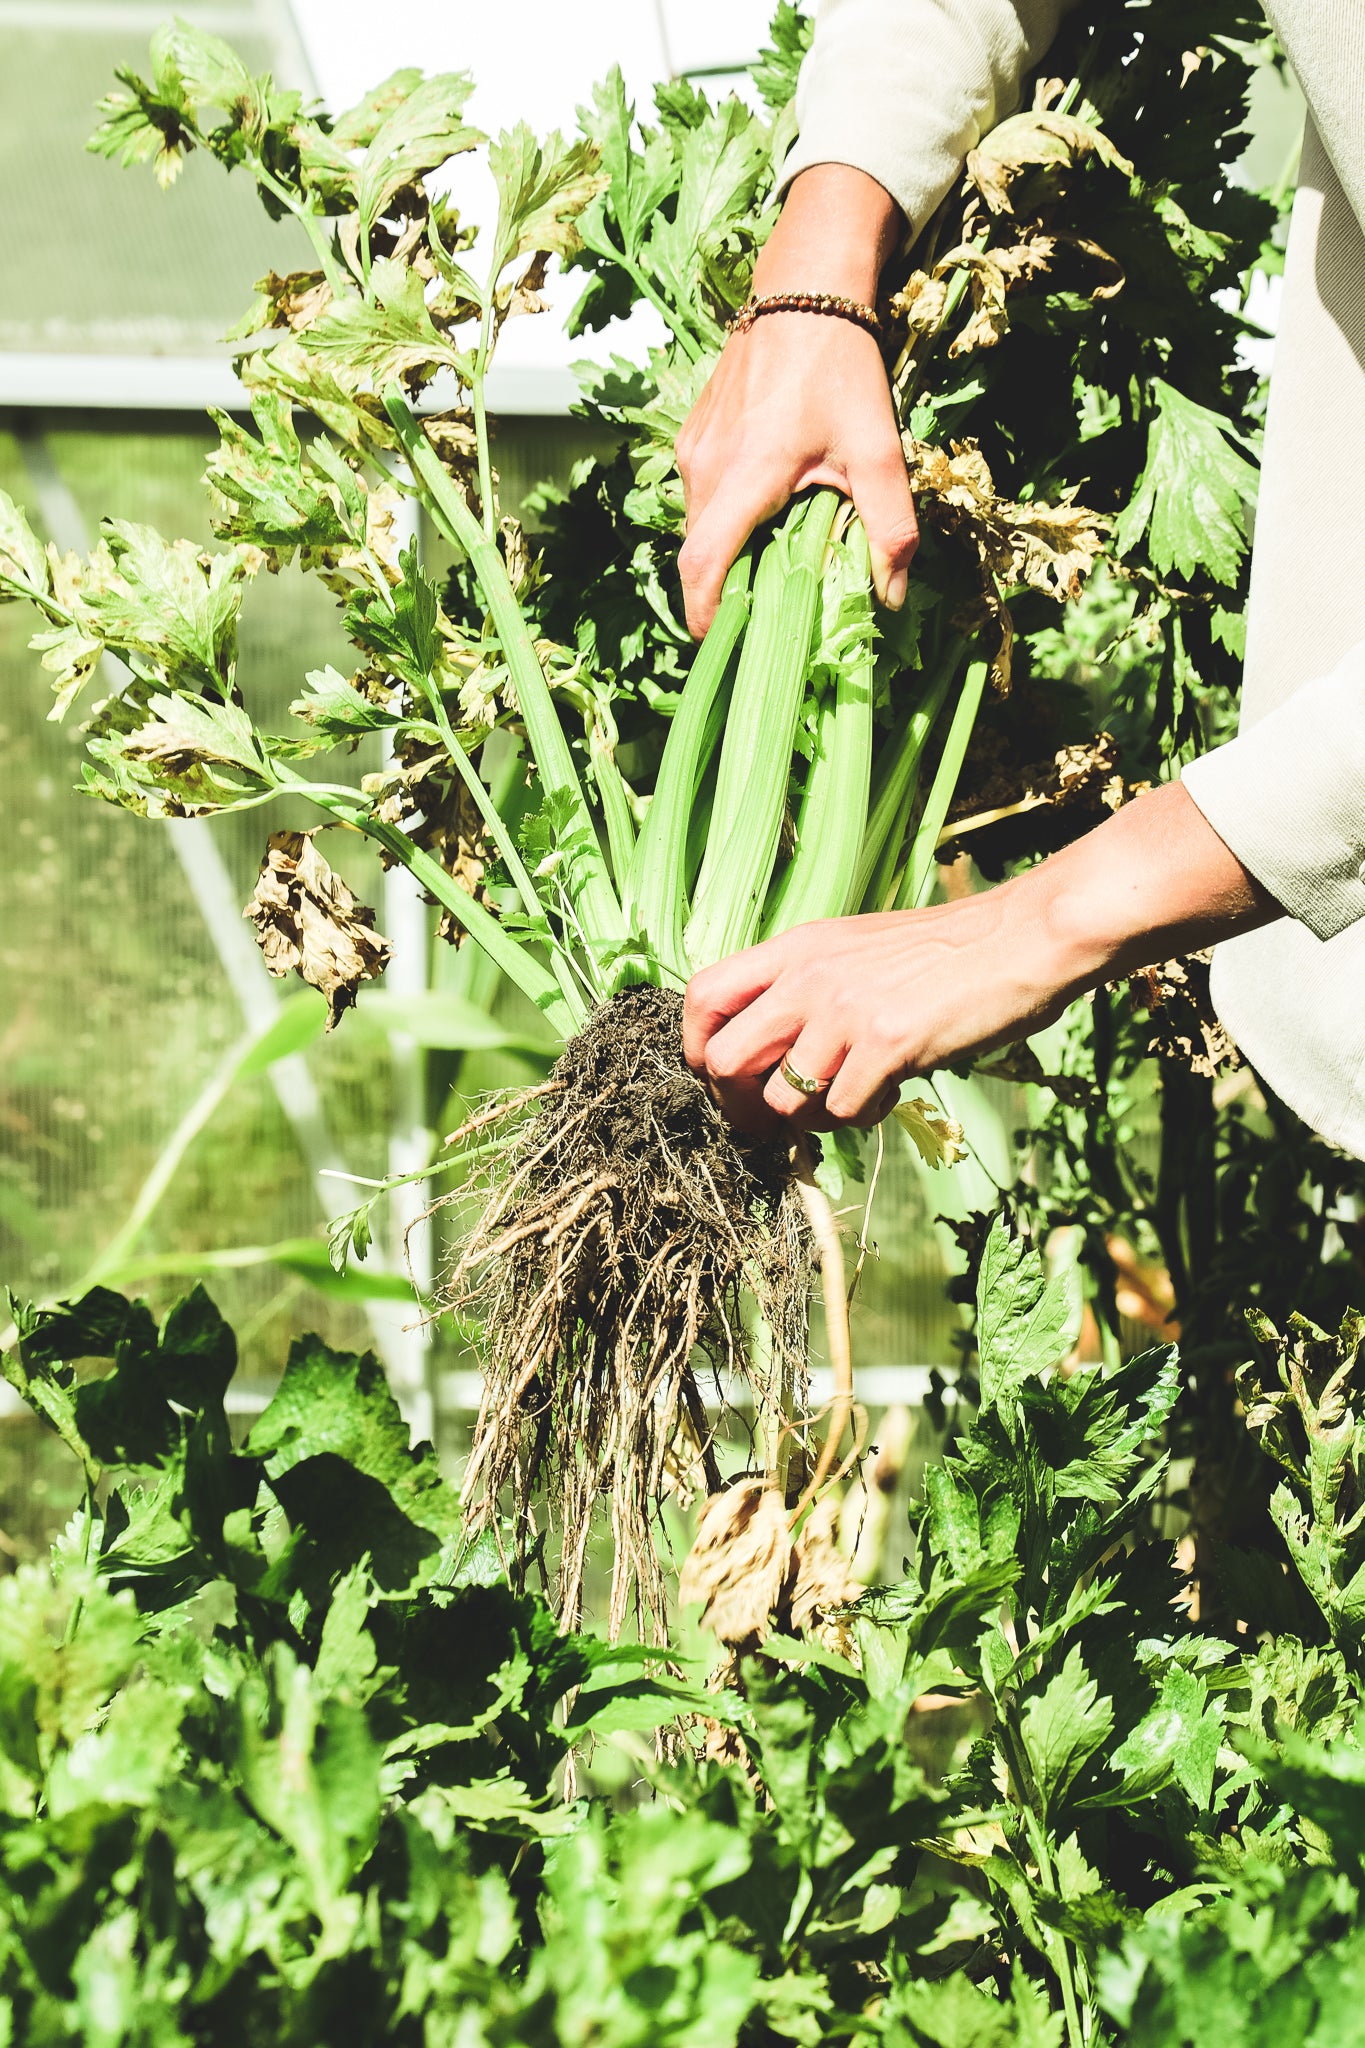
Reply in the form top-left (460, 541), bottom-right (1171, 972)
top-left (684, 782), bottom-right (1281, 1135)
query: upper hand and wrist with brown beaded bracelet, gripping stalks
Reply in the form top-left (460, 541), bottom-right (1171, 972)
top-left (677, 164), bottom-right (919, 639)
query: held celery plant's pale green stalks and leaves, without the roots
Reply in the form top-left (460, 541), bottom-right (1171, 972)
top-left (0, 23), bottom-right (1129, 1073)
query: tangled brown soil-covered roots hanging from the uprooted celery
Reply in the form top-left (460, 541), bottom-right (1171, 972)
top-left (446, 987), bottom-right (812, 1640)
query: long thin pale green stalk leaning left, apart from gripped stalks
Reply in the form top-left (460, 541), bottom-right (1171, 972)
top-left (385, 383), bottom-right (624, 944)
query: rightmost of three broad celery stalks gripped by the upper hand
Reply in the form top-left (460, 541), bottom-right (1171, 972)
top-left (763, 520), bottom-right (876, 938)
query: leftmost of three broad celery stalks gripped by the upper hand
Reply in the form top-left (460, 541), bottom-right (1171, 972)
top-left (624, 551), bottom-right (753, 987)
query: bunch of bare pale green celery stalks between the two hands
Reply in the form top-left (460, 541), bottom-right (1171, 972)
top-left (384, 385), bottom-right (988, 1036)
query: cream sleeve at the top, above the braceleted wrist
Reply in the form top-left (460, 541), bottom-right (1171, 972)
top-left (782, 0), bottom-right (1066, 231)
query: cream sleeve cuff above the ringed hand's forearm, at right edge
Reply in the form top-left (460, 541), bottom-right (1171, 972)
top-left (1181, 641), bottom-right (1365, 938)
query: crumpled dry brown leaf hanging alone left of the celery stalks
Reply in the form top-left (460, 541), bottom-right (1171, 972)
top-left (244, 831), bottom-right (393, 1030)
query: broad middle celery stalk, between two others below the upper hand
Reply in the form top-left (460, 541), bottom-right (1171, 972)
top-left (686, 492), bottom-right (839, 967)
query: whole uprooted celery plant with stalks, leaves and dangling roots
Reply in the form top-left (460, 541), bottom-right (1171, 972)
top-left (0, 8), bottom-right (1195, 1626)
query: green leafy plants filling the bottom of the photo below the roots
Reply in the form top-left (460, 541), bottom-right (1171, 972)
top-left (0, 1225), bottom-right (1365, 2048)
